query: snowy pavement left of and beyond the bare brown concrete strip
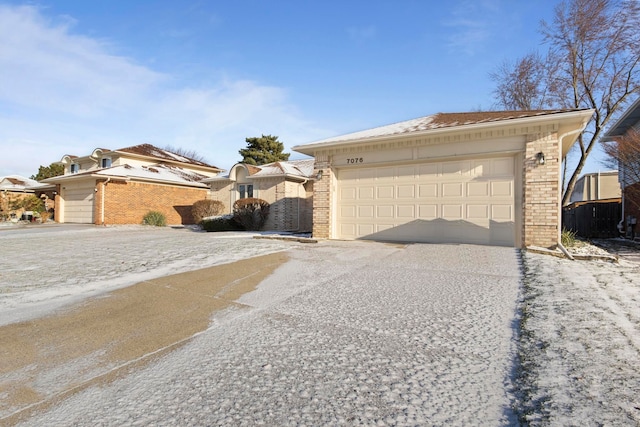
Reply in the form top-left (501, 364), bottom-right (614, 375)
top-left (0, 225), bottom-right (291, 325)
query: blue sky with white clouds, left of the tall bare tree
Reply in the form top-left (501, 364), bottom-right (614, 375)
top-left (0, 0), bottom-right (603, 176)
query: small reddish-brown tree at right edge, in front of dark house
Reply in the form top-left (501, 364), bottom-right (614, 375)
top-left (602, 129), bottom-right (640, 209)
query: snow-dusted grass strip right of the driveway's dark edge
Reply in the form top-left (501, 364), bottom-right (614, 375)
top-left (518, 249), bottom-right (640, 426)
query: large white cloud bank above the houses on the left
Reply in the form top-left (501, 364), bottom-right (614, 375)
top-left (0, 5), bottom-right (326, 176)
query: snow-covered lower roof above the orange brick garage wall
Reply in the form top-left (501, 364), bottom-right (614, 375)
top-left (93, 163), bottom-right (207, 187)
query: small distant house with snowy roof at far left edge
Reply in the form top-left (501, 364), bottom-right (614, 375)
top-left (0, 175), bottom-right (54, 220)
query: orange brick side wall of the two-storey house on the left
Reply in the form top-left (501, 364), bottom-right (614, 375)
top-left (94, 181), bottom-right (209, 225)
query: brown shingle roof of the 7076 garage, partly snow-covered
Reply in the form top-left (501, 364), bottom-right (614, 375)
top-left (302, 110), bottom-right (578, 144)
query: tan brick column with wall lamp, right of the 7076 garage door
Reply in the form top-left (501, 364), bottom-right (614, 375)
top-left (522, 133), bottom-right (561, 248)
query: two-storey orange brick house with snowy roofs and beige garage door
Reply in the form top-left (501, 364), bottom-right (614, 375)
top-left (42, 144), bottom-right (222, 225)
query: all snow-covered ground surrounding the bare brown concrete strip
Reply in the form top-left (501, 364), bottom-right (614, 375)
top-left (0, 227), bottom-right (640, 426)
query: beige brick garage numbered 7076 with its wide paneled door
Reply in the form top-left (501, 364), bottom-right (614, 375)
top-left (293, 110), bottom-right (593, 247)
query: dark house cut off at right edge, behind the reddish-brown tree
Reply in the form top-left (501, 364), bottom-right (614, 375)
top-left (602, 98), bottom-right (640, 238)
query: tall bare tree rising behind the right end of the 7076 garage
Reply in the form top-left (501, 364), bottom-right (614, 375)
top-left (494, 0), bottom-right (640, 205)
